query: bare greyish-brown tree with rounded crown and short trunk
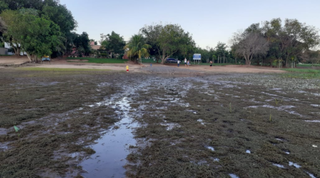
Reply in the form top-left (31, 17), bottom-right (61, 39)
top-left (235, 32), bottom-right (269, 65)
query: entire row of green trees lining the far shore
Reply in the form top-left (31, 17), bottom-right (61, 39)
top-left (0, 0), bottom-right (320, 67)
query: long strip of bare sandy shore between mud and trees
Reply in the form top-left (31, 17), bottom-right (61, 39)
top-left (0, 56), bottom-right (285, 73)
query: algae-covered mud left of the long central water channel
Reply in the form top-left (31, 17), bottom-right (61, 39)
top-left (0, 69), bottom-right (121, 177)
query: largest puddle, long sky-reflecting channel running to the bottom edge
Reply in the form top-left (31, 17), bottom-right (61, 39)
top-left (80, 97), bottom-right (138, 177)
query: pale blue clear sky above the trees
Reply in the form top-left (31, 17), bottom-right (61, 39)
top-left (60, 0), bottom-right (320, 48)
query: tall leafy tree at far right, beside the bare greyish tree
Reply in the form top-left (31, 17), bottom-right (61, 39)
top-left (263, 18), bottom-right (320, 67)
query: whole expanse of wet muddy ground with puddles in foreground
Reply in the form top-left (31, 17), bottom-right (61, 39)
top-left (0, 69), bottom-right (320, 177)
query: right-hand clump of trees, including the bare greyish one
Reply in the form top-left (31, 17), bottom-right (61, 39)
top-left (231, 18), bottom-right (320, 67)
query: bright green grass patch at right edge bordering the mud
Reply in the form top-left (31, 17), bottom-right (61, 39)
top-left (282, 68), bottom-right (320, 79)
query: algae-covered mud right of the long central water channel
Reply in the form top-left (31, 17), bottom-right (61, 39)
top-left (127, 77), bottom-right (320, 177)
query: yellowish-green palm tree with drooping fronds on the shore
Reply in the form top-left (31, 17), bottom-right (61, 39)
top-left (124, 35), bottom-right (151, 63)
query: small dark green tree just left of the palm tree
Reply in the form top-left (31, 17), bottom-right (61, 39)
top-left (101, 31), bottom-right (126, 58)
